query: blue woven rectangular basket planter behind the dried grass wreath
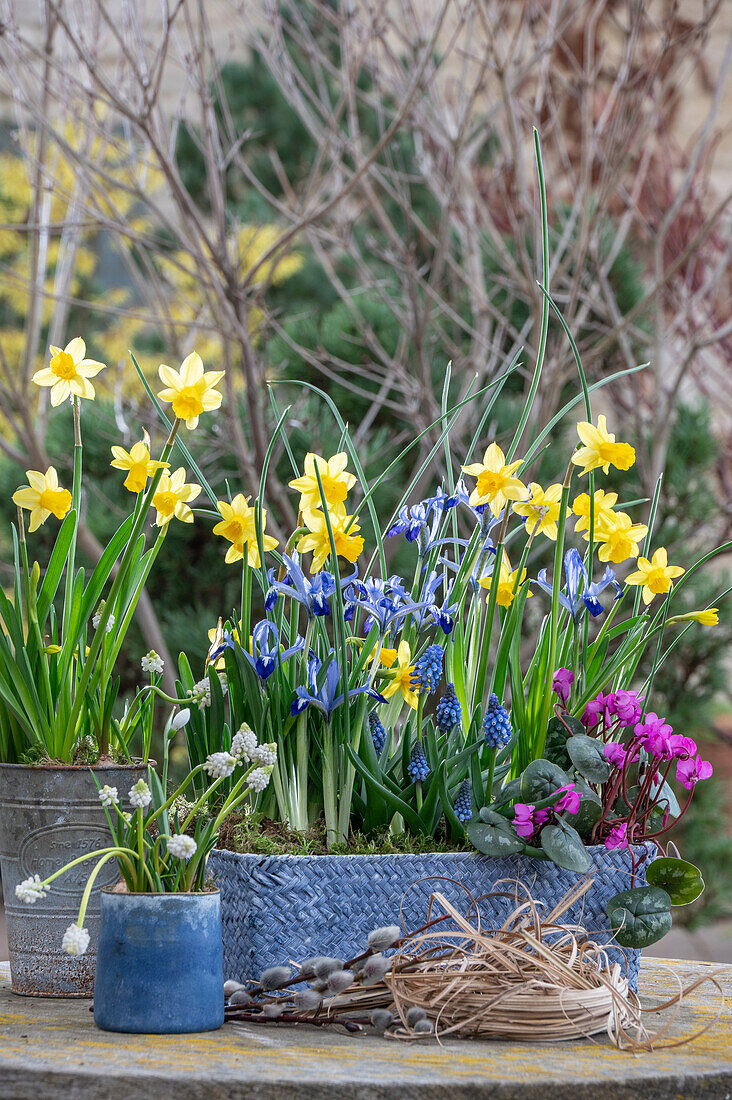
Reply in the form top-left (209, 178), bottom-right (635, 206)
top-left (208, 844), bottom-right (656, 989)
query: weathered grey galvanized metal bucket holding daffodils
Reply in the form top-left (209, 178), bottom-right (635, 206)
top-left (0, 763), bottom-right (148, 997)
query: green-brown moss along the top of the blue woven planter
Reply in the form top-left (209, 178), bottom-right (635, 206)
top-left (217, 814), bottom-right (474, 856)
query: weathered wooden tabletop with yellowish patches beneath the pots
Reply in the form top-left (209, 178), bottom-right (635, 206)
top-left (0, 959), bottom-right (732, 1100)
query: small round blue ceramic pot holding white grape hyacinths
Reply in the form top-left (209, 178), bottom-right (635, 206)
top-left (94, 888), bottom-right (223, 1034)
